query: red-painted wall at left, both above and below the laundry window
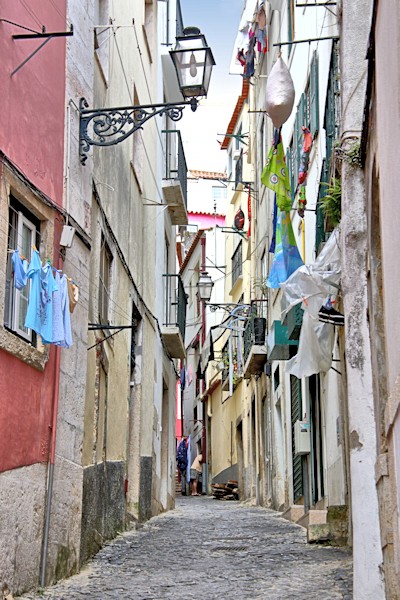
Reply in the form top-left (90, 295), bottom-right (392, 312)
top-left (0, 0), bottom-right (66, 472)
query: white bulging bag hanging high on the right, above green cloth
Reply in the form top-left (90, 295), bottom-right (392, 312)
top-left (265, 57), bottom-right (295, 129)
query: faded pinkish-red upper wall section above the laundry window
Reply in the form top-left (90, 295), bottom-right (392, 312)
top-left (0, 0), bottom-right (66, 204)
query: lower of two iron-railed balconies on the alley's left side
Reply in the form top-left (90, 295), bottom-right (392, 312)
top-left (161, 274), bottom-right (187, 358)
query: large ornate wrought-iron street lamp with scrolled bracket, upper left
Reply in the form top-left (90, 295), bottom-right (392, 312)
top-left (79, 27), bottom-right (215, 165)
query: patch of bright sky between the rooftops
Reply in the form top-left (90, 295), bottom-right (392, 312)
top-left (179, 0), bottom-right (243, 172)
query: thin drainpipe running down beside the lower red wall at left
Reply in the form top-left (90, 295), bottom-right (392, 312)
top-left (40, 296), bottom-right (61, 587)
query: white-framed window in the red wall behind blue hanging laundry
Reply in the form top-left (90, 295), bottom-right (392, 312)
top-left (4, 196), bottom-right (40, 343)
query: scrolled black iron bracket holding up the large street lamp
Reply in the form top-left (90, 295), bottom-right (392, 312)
top-left (79, 98), bottom-right (198, 165)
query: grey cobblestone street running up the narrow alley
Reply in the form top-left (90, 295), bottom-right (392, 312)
top-left (18, 497), bottom-right (352, 600)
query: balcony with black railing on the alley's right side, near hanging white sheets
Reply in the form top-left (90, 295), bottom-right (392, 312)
top-left (243, 300), bottom-right (268, 379)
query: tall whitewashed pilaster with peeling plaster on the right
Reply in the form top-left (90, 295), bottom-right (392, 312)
top-left (340, 0), bottom-right (385, 600)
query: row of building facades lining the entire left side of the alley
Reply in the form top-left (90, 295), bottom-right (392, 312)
top-left (0, 0), bottom-right (192, 593)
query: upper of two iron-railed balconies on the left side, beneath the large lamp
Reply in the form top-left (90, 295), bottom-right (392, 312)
top-left (162, 129), bottom-right (188, 225)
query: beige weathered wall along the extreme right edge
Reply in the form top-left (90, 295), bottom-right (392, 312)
top-left (365, 0), bottom-right (400, 599)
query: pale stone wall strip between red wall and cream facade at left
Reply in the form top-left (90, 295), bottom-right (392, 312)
top-left (45, 0), bottom-right (94, 584)
